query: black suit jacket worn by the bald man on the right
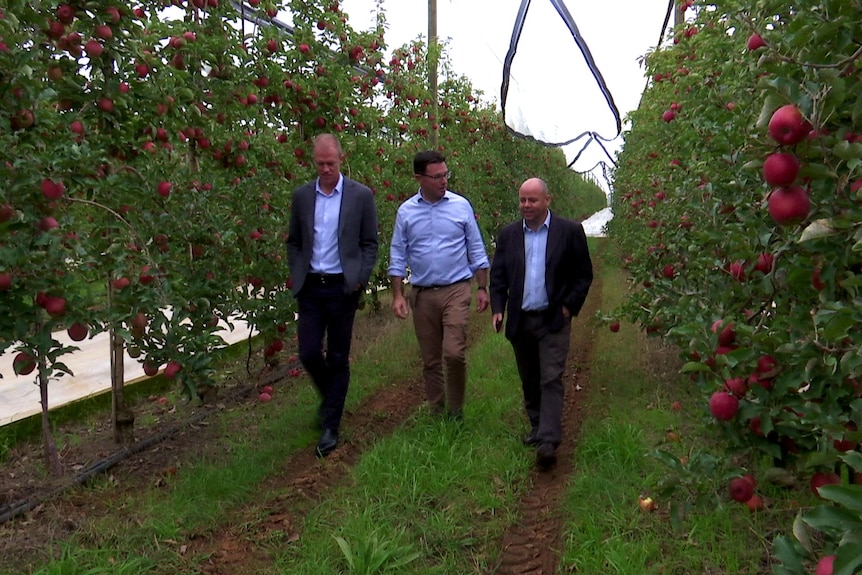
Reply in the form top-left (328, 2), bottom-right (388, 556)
top-left (489, 213), bottom-right (593, 340)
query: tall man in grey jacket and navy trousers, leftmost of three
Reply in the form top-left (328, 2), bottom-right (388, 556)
top-left (287, 134), bottom-right (378, 457)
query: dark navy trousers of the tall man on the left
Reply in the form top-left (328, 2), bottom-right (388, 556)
top-left (296, 281), bottom-right (359, 431)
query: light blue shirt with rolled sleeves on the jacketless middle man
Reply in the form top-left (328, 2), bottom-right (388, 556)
top-left (387, 190), bottom-right (489, 286)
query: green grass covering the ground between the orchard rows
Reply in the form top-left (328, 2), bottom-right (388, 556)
top-left (5, 237), bottom-right (824, 575)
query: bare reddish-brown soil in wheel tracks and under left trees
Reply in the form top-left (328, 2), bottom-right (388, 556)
top-left (0, 264), bottom-right (640, 575)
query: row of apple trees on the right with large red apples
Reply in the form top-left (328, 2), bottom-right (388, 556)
top-left (611, 0), bottom-right (862, 575)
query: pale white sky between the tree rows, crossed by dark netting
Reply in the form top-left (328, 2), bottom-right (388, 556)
top-left (342, 0), bottom-right (672, 196)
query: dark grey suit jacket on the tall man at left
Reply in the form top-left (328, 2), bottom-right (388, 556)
top-left (287, 177), bottom-right (377, 295)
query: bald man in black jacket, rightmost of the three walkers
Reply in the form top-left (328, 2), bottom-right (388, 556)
top-left (489, 178), bottom-right (593, 468)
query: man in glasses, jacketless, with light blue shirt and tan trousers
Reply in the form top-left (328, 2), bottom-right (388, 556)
top-left (388, 151), bottom-right (489, 421)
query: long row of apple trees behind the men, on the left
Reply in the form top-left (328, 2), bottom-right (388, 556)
top-left (0, 0), bottom-right (605, 473)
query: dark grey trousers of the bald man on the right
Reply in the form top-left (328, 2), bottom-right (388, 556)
top-left (512, 316), bottom-right (572, 446)
